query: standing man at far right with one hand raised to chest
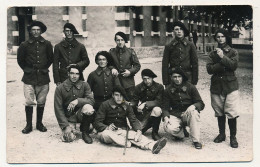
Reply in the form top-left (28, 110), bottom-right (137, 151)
top-left (207, 29), bottom-right (239, 148)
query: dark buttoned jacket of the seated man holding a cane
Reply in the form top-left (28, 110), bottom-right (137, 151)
top-left (94, 98), bottom-right (141, 132)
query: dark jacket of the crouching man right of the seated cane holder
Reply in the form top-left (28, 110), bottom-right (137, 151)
top-left (131, 81), bottom-right (164, 110)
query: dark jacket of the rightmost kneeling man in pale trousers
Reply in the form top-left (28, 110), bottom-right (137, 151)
top-left (162, 82), bottom-right (205, 118)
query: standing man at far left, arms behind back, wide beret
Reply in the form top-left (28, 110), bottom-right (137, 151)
top-left (17, 21), bottom-right (53, 134)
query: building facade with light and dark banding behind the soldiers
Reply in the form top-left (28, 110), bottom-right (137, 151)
top-left (7, 6), bottom-right (239, 54)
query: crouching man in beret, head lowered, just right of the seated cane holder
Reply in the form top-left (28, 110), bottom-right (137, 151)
top-left (131, 69), bottom-right (164, 141)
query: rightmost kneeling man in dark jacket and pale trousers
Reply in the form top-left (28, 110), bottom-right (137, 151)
top-left (162, 69), bottom-right (205, 149)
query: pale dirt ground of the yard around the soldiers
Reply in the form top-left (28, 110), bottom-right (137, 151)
top-left (6, 50), bottom-right (253, 163)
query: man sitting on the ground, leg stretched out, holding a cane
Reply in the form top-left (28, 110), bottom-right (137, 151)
top-left (94, 86), bottom-right (167, 154)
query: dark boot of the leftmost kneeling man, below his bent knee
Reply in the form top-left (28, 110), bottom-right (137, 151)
top-left (80, 114), bottom-right (94, 144)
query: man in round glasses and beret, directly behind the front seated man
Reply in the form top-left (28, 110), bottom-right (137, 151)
top-left (87, 51), bottom-right (120, 111)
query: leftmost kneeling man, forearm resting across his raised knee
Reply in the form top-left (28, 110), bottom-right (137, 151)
top-left (54, 65), bottom-right (94, 144)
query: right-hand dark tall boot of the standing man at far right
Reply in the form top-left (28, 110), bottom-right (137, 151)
top-left (228, 118), bottom-right (238, 148)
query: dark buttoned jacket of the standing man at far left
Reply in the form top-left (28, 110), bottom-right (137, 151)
top-left (17, 37), bottom-right (53, 85)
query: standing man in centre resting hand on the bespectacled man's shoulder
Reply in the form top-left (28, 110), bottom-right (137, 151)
top-left (109, 32), bottom-right (141, 101)
